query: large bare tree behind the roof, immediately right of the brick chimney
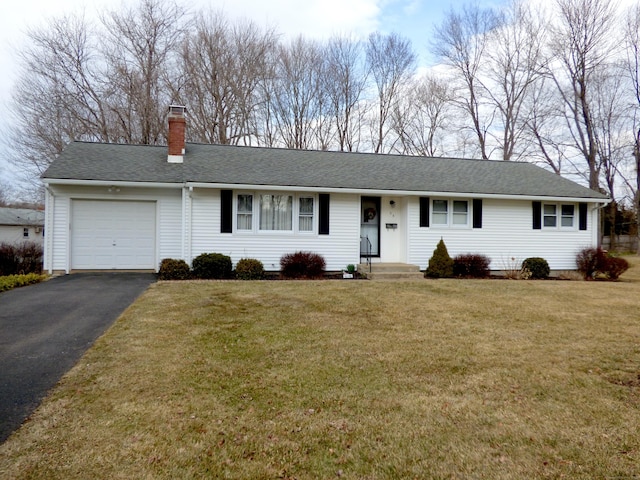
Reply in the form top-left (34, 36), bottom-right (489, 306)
top-left (179, 12), bottom-right (276, 144)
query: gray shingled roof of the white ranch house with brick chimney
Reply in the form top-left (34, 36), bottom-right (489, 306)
top-left (43, 142), bottom-right (606, 199)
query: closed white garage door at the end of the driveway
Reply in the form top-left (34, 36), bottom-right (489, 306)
top-left (71, 200), bottom-right (156, 270)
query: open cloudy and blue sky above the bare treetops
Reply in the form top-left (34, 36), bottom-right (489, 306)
top-left (0, 0), bottom-right (506, 186)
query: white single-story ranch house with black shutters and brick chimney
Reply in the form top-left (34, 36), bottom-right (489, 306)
top-left (43, 107), bottom-right (609, 272)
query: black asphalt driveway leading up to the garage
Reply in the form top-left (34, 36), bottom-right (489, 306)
top-left (0, 273), bottom-right (155, 443)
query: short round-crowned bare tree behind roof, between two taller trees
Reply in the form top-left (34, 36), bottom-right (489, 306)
top-left (393, 75), bottom-right (452, 157)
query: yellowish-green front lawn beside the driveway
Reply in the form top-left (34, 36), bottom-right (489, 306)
top-left (0, 257), bottom-right (640, 479)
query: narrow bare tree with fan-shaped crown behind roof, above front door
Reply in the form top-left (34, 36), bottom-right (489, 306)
top-left (366, 32), bottom-right (416, 153)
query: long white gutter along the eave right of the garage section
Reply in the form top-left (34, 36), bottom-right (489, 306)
top-left (186, 182), bottom-right (611, 205)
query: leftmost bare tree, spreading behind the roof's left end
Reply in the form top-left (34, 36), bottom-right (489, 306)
top-left (9, 16), bottom-right (107, 178)
